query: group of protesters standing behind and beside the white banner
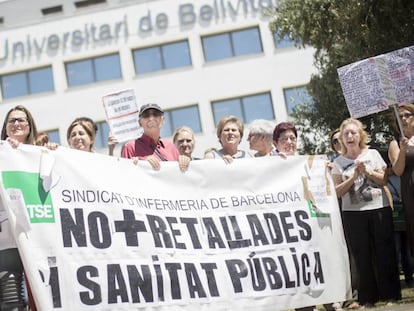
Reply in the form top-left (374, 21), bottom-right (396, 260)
top-left (1, 103), bottom-right (414, 310)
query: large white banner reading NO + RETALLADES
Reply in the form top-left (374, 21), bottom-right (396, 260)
top-left (0, 143), bottom-right (350, 311)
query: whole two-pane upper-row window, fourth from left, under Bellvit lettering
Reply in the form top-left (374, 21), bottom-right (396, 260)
top-left (202, 27), bottom-right (263, 62)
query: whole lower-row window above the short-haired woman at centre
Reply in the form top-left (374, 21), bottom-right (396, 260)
top-left (212, 93), bottom-right (275, 124)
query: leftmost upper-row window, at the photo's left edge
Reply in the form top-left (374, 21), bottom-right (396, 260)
top-left (0, 66), bottom-right (55, 99)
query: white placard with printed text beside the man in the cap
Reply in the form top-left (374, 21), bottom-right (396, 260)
top-left (102, 90), bottom-right (141, 142)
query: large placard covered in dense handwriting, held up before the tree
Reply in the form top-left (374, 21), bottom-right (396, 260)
top-left (338, 46), bottom-right (414, 118)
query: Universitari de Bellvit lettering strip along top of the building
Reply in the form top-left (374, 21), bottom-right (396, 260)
top-left (0, 0), bottom-right (278, 61)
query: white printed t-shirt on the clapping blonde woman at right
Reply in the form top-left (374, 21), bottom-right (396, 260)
top-left (332, 149), bottom-right (389, 211)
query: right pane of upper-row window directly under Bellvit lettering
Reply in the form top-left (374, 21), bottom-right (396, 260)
top-left (232, 28), bottom-right (262, 56)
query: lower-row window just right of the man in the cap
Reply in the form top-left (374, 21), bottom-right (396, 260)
top-left (161, 105), bottom-right (201, 137)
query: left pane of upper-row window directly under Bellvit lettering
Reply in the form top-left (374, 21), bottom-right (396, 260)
top-left (203, 33), bottom-right (233, 62)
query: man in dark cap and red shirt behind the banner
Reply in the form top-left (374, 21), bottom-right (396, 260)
top-left (121, 103), bottom-right (189, 170)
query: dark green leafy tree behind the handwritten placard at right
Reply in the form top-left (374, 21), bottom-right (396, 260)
top-left (270, 0), bottom-right (414, 153)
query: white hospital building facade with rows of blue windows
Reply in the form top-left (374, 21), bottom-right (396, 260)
top-left (0, 0), bottom-right (315, 157)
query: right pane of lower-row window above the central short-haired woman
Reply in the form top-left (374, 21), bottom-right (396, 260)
top-left (242, 93), bottom-right (275, 123)
